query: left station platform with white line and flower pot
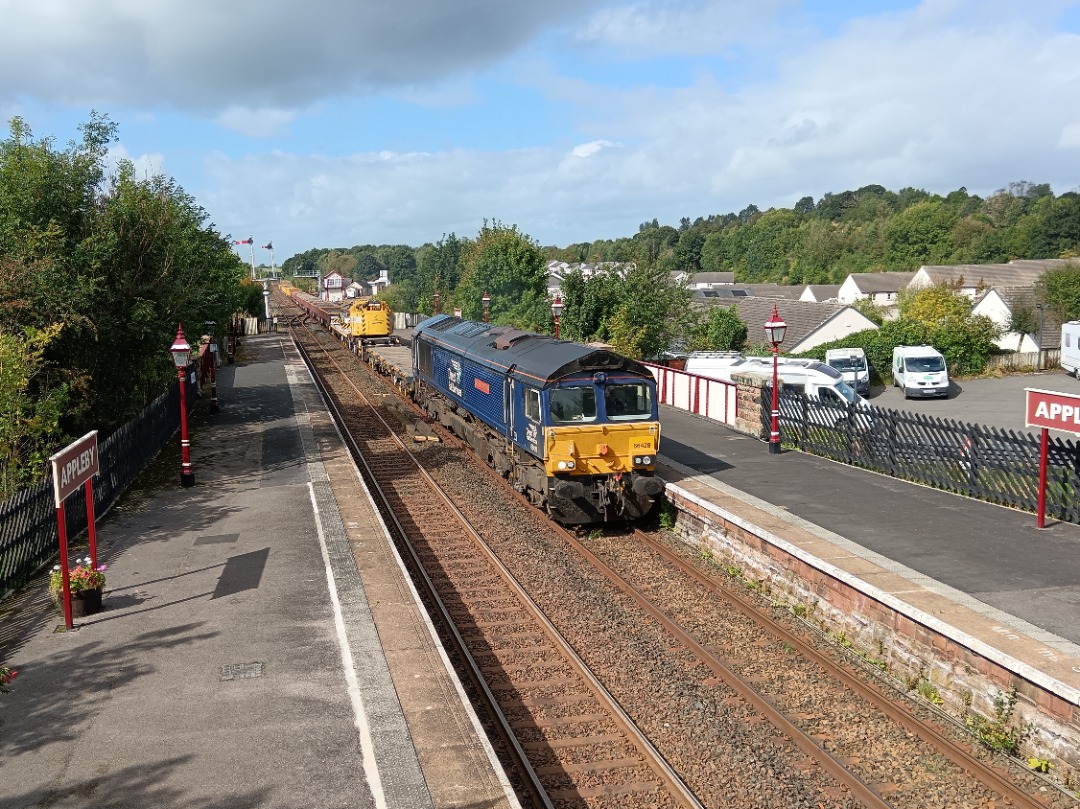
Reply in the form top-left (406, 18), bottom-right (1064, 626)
top-left (0, 334), bottom-right (517, 809)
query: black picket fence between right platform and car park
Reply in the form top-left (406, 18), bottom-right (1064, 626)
top-left (761, 388), bottom-right (1080, 523)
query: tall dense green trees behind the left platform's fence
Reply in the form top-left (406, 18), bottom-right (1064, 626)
top-left (0, 112), bottom-right (261, 498)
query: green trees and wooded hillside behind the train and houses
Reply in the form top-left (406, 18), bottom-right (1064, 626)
top-left (283, 181), bottom-right (1080, 368)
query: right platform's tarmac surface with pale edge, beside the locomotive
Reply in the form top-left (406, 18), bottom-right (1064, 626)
top-left (658, 406), bottom-right (1080, 704)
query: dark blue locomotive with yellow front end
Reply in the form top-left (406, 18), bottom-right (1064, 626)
top-left (413, 314), bottom-right (663, 525)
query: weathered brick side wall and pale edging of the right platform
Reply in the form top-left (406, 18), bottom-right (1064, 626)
top-left (657, 456), bottom-right (1080, 772)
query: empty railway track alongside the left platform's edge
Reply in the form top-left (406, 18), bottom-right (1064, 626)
top-left (298, 321), bottom-right (700, 807)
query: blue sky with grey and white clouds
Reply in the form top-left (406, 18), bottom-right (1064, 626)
top-left (0, 0), bottom-right (1080, 265)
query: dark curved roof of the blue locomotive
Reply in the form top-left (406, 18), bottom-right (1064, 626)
top-left (414, 314), bottom-right (649, 385)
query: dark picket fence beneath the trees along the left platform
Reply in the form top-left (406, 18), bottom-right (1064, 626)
top-left (0, 374), bottom-right (199, 597)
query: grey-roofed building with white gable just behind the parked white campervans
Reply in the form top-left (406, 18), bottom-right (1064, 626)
top-left (690, 291), bottom-right (877, 354)
